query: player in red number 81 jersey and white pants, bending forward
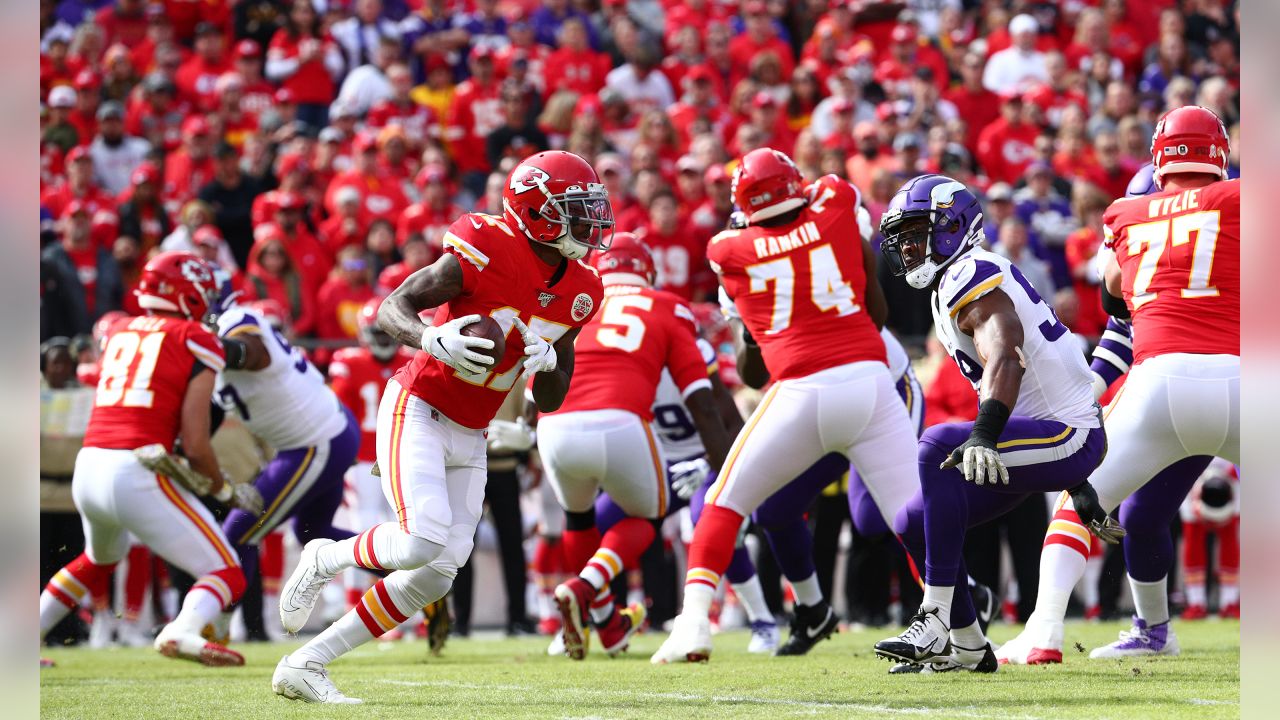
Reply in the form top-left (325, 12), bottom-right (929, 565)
top-left (40, 252), bottom-right (261, 666)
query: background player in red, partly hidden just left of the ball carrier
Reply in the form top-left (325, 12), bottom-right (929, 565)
top-left (329, 297), bottom-right (412, 609)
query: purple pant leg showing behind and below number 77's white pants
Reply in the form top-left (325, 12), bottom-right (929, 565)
top-left (1120, 455), bottom-right (1213, 583)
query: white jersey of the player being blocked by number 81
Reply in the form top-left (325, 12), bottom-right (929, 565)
top-left (215, 307), bottom-right (347, 450)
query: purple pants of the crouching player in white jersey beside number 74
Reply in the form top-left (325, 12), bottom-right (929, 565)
top-left (895, 415), bottom-right (1107, 628)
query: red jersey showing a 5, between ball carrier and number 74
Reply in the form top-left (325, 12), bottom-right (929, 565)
top-left (557, 284), bottom-right (710, 423)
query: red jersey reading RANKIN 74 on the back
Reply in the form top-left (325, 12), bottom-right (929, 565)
top-left (707, 176), bottom-right (886, 380)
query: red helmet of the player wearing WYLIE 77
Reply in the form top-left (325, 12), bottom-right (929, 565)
top-left (1151, 105), bottom-right (1231, 187)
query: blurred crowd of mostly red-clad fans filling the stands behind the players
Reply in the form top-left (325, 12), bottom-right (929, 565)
top-left (40, 0), bottom-right (1240, 632)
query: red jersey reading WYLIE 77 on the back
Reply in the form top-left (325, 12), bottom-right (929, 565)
top-left (1102, 179), bottom-right (1240, 365)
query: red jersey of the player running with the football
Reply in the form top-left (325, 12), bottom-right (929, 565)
top-left (396, 213), bottom-right (604, 429)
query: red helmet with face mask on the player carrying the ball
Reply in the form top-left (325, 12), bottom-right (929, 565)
top-left (502, 150), bottom-right (613, 259)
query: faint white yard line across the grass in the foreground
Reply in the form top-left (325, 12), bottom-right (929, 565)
top-left (378, 679), bottom-right (1042, 720)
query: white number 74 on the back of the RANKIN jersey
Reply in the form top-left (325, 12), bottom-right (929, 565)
top-left (746, 245), bottom-right (861, 334)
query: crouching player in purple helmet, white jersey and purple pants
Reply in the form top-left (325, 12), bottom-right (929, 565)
top-left (876, 174), bottom-right (1123, 673)
